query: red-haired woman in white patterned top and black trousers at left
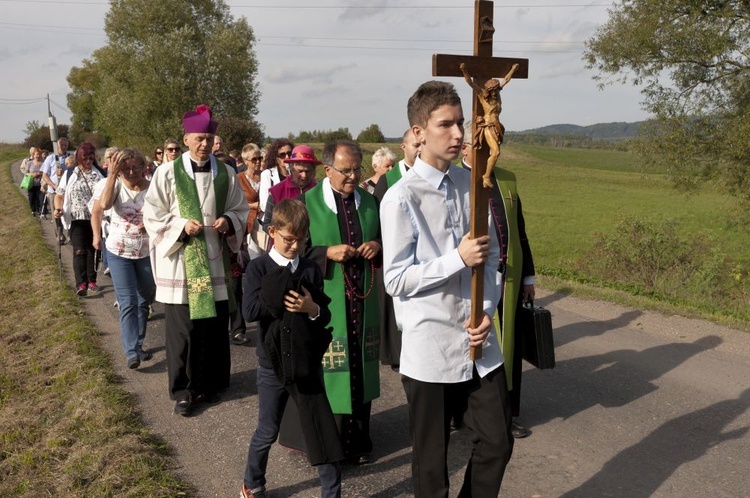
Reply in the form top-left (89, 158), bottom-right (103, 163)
top-left (54, 142), bottom-right (104, 296)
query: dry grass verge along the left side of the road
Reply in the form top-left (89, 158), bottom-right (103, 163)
top-left (0, 156), bottom-right (192, 498)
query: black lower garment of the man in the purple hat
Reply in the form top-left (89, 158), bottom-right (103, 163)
top-left (164, 301), bottom-right (231, 399)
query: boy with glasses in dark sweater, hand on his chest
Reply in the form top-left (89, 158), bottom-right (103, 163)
top-left (241, 199), bottom-right (343, 498)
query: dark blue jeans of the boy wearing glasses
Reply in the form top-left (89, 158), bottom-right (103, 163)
top-left (244, 366), bottom-right (341, 498)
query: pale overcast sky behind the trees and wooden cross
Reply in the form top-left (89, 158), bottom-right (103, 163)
top-left (0, 0), bottom-right (647, 142)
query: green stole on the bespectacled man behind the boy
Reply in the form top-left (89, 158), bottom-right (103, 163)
top-left (304, 182), bottom-right (380, 414)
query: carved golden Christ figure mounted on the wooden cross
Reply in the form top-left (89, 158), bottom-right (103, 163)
top-left (459, 63), bottom-right (518, 188)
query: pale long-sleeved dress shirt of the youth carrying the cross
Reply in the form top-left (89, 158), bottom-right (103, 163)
top-left (380, 157), bottom-right (503, 383)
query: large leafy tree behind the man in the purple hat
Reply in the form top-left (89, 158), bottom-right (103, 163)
top-left (68, 0), bottom-right (259, 150)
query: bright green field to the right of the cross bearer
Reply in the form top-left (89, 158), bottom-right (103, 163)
top-left (500, 146), bottom-right (750, 269)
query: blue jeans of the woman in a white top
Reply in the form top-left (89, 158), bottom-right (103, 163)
top-left (105, 249), bottom-right (154, 360)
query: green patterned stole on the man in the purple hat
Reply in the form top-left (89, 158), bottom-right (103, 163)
top-left (174, 156), bottom-right (232, 320)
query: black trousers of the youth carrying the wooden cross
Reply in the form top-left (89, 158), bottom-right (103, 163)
top-left (401, 365), bottom-right (513, 498)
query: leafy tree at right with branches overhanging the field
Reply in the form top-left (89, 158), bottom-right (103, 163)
top-left (584, 0), bottom-right (750, 201)
